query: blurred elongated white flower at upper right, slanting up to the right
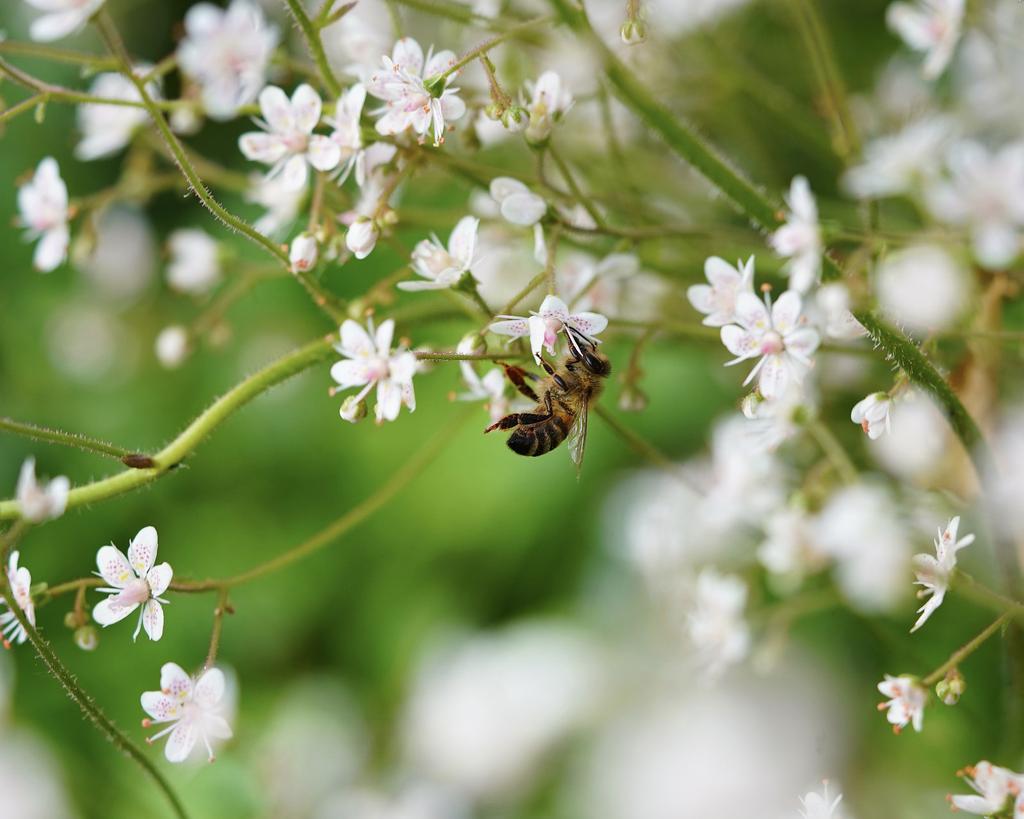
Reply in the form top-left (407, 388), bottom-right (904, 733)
top-left (843, 117), bottom-right (952, 199)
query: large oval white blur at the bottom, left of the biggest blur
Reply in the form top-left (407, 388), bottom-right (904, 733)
top-left (404, 622), bottom-right (602, 800)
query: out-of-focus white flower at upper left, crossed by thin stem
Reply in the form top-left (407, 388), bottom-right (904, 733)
top-left (75, 66), bottom-right (160, 162)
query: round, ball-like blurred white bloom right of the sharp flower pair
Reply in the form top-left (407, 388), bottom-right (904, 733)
top-left (876, 245), bottom-right (968, 333)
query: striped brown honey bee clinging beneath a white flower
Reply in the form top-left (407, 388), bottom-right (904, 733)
top-left (483, 328), bottom-right (611, 471)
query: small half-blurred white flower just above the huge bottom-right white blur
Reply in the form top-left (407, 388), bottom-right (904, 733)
top-left (688, 568), bottom-right (751, 677)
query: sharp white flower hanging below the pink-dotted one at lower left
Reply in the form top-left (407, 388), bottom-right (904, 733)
top-left (140, 662), bottom-right (231, 762)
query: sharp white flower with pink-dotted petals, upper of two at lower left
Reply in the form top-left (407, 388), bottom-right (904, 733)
top-left (92, 526), bottom-right (174, 640)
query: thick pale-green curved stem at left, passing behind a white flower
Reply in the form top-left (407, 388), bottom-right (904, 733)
top-left (0, 336), bottom-right (336, 520)
